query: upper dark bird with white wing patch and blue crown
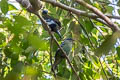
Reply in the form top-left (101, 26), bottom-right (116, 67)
top-left (42, 10), bottom-right (62, 38)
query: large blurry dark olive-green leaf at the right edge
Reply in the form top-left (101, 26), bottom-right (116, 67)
top-left (95, 31), bottom-right (120, 56)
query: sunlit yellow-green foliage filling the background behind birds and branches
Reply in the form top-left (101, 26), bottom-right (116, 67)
top-left (0, 0), bottom-right (120, 80)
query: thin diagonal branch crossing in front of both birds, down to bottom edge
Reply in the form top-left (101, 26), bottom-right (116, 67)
top-left (17, 0), bottom-right (81, 80)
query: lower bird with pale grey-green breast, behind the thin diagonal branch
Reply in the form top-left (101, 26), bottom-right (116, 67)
top-left (51, 38), bottom-right (74, 72)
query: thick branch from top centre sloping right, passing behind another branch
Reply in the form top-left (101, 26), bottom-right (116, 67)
top-left (41, 0), bottom-right (120, 19)
